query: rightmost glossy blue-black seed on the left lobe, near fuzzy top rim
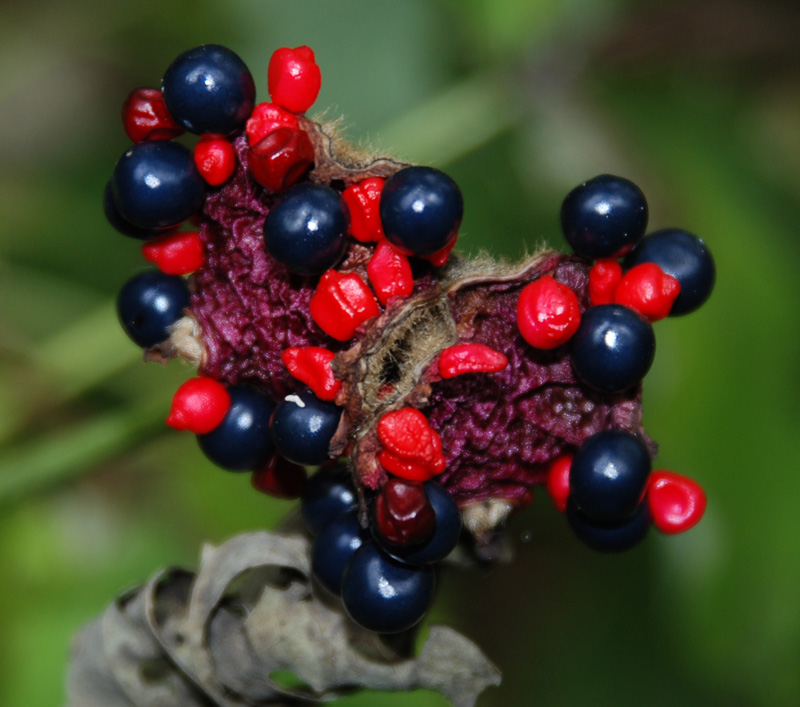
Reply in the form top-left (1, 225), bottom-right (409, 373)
top-left (380, 167), bottom-right (464, 255)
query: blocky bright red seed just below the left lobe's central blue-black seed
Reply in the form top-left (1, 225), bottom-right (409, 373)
top-left (309, 270), bottom-right (381, 341)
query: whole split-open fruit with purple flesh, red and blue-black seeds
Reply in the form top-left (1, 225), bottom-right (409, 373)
top-left (104, 45), bottom-right (714, 632)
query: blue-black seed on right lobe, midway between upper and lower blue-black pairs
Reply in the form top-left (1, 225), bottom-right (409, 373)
top-left (570, 304), bottom-right (656, 393)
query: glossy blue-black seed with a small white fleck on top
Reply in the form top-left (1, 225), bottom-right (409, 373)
top-left (270, 391), bottom-right (342, 466)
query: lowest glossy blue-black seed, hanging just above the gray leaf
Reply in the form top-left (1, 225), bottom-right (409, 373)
top-left (342, 541), bottom-right (436, 633)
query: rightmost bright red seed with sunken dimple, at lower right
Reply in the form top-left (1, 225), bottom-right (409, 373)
top-left (647, 471), bottom-right (706, 535)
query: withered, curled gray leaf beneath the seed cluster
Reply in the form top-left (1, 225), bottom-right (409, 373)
top-left (67, 532), bottom-right (500, 707)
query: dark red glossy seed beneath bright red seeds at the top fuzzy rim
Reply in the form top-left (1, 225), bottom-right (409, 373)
top-left (247, 127), bottom-right (314, 192)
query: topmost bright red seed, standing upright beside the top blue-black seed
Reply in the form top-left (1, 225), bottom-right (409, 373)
top-left (267, 46), bottom-right (322, 113)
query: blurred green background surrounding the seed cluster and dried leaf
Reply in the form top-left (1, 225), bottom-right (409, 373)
top-left (0, 0), bottom-right (800, 707)
